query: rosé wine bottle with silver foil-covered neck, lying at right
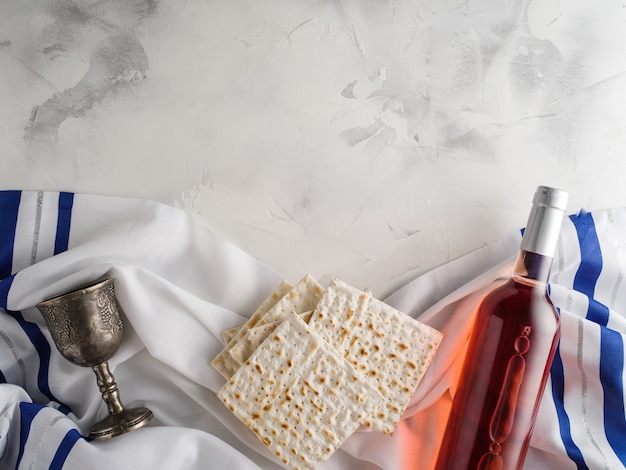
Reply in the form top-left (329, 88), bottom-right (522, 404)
top-left (436, 186), bottom-right (567, 470)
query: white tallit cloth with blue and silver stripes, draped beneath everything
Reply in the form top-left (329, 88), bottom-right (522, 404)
top-left (0, 191), bottom-right (626, 470)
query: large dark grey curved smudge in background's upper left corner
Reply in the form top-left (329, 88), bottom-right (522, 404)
top-left (25, 0), bottom-right (156, 141)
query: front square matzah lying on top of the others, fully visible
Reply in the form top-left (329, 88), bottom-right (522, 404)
top-left (217, 314), bottom-right (382, 469)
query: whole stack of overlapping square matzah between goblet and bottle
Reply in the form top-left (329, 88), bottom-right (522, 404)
top-left (211, 275), bottom-right (442, 469)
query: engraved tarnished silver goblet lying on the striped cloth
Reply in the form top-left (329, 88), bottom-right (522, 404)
top-left (37, 279), bottom-right (152, 439)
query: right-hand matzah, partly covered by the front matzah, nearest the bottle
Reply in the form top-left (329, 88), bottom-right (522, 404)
top-left (309, 279), bottom-right (442, 434)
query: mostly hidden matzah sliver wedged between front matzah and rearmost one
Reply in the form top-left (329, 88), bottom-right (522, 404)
top-left (211, 274), bottom-right (324, 379)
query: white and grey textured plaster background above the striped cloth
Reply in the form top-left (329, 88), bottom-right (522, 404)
top-left (0, 0), bottom-right (626, 296)
